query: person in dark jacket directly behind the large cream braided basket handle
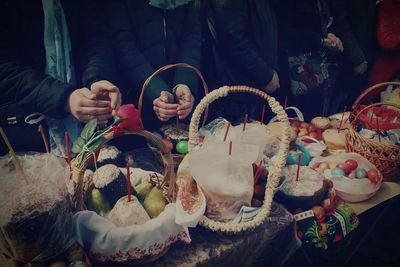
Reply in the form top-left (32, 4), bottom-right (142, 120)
top-left (208, 0), bottom-right (280, 120)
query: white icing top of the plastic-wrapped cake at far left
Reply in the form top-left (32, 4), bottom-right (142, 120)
top-left (0, 153), bottom-right (69, 227)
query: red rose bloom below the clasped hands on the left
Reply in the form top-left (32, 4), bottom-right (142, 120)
top-left (117, 104), bottom-right (143, 132)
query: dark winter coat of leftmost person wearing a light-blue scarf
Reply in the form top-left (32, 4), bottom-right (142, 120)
top-left (0, 0), bottom-right (112, 124)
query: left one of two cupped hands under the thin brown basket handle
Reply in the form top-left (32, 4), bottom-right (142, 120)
top-left (153, 91), bottom-right (179, 121)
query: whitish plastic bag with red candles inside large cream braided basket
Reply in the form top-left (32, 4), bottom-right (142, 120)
top-left (189, 142), bottom-right (258, 221)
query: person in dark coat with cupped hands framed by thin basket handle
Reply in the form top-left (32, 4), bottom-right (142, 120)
top-left (104, 0), bottom-right (202, 129)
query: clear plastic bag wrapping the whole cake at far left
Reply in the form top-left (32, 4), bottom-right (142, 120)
top-left (0, 153), bottom-right (74, 262)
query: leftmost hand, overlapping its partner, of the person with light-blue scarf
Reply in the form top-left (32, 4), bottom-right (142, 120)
top-left (65, 88), bottom-right (112, 124)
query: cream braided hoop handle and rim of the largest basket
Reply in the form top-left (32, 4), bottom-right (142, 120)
top-left (189, 86), bottom-right (290, 234)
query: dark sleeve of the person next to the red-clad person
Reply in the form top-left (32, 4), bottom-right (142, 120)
top-left (331, 0), bottom-right (366, 67)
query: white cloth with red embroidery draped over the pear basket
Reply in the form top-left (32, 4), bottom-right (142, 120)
top-left (73, 204), bottom-right (191, 263)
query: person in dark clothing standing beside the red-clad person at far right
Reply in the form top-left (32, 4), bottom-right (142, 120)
top-left (330, 0), bottom-right (376, 110)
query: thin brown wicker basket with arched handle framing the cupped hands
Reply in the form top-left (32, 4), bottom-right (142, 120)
top-left (138, 63), bottom-right (208, 169)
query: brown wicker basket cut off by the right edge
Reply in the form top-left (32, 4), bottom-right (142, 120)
top-left (346, 82), bottom-right (400, 181)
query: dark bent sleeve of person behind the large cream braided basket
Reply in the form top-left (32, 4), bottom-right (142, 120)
top-left (213, 0), bottom-right (274, 86)
